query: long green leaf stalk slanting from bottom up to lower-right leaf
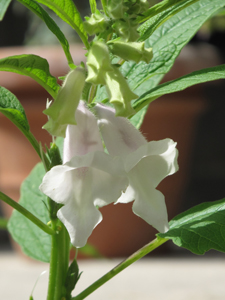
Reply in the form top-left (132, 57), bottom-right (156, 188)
top-left (71, 237), bottom-right (168, 300)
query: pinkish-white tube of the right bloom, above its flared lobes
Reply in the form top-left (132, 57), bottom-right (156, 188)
top-left (95, 104), bottom-right (147, 156)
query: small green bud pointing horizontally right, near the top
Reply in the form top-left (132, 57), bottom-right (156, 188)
top-left (108, 39), bottom-right (153, 64)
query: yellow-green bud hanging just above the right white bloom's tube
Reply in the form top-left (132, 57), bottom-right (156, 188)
top-left (106, 67), bottom-right (138, 117)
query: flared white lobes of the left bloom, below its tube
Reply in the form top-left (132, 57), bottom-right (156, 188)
top-left (40, 151), bottom-right (128, 247)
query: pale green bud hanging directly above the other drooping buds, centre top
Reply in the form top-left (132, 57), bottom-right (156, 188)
top-left (86, 41), bottom-right (113, 85)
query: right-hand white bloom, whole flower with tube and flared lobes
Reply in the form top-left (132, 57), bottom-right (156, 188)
top-left (95, 104), bottom-right (178, 232)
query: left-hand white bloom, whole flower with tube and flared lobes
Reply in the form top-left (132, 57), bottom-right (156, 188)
top-left (40, 101), bottom-right (128, 247)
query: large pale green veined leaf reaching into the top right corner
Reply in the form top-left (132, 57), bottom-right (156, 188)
top-left (120, 0), bottom-right (225, 96)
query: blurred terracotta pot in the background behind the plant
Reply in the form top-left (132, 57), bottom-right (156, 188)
top-left (0, 46), bottom-right (218, 257)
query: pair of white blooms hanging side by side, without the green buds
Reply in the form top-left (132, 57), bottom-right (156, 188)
top-left (40, 101), bottom-right (178, 247)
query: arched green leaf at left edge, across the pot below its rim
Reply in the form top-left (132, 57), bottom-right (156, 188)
top-left (0, 54), bottom-right (60, 98)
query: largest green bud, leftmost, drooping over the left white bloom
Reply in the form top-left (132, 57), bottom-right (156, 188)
top-left (43, 67), bottom-right (85, 137)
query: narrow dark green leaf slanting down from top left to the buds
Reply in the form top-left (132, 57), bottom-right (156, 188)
top-left (17, 0), bottom-right (73, 64)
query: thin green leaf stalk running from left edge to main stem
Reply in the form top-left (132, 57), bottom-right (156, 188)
top-left (0, 192), bottom-right (55, 235)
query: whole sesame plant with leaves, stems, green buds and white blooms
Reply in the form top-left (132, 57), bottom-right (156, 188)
top-left (0, 0), bottom-right (225, 300)
